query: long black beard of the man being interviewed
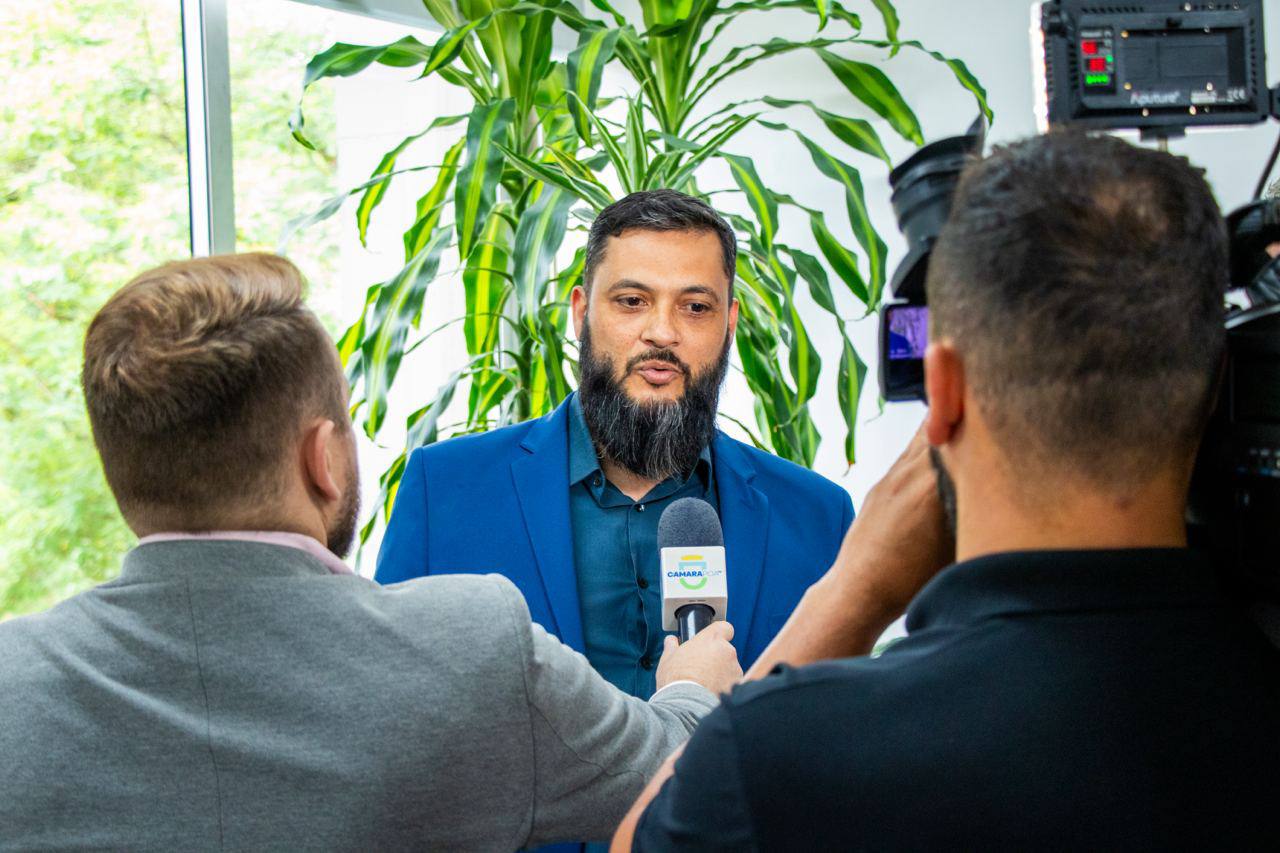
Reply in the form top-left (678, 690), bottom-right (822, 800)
top-left (579, 318), bottom-right (732, 480)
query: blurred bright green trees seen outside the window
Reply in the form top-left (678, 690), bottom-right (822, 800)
top-left (0, 0), bottom-right (337, 619)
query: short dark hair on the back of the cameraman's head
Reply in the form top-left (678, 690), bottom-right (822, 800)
top-left (927, 131), bottom-right (1228, 485)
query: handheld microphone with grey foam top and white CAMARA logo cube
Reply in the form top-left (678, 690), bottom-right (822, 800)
top-left (658, 498), bottom-right (728, 643)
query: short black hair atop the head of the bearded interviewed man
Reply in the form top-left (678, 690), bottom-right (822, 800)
top-left (582, 190), bottom-right (737, 293)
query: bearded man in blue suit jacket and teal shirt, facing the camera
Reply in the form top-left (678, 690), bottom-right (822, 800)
top-left (376, 190), bottom-right (852, 697)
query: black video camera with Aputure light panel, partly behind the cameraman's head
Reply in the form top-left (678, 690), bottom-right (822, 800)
top-left (879, 0), bottom-right (1280, 598)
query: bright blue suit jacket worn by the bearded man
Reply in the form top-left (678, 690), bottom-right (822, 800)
top-left (375, 391), bottom-right (854, 669)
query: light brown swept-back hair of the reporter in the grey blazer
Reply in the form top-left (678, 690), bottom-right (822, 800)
top-left (82, 254), bottom-right (349, 528)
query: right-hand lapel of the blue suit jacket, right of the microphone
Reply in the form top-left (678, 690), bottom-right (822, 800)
top-left (712, 433), bottom-right (769, 657)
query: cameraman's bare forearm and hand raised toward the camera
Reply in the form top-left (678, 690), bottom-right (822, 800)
top-left (746, 428), bottom-right (955, 679)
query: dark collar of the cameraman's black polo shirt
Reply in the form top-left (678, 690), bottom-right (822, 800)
top-left (906, 548), bottom-right (1225, 631)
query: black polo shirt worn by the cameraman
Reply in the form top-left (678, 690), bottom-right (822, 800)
top-left (635, 549), bottom-right (1280, 850)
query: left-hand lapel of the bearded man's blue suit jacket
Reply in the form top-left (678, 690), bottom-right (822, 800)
top-left (511, 401), bottom-right (585, 652)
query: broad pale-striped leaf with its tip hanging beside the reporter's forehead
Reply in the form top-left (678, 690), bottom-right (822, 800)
top-left (361, 228), bottom-right (449, 438)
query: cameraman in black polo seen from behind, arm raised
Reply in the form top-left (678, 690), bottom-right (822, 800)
top-left (614, 133), bottom-right (1280, 850)
